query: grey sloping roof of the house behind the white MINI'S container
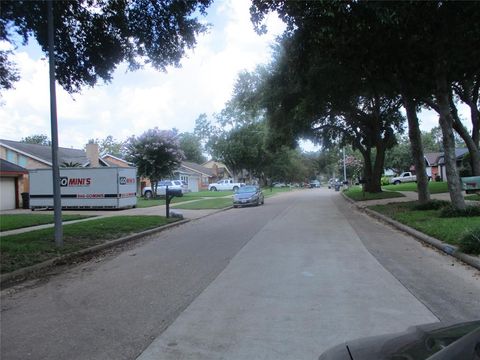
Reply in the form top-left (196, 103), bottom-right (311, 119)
top-left (0, 139), bottom-right (108, 166)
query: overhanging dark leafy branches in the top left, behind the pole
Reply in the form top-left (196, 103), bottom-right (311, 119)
top-left (0, 0), bottom-right (212, 93)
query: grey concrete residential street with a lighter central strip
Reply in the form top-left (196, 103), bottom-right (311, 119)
top-left (1, 188), bottom-right (480, 360)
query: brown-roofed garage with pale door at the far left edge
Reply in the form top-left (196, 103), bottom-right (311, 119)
top-left (0, 159), bottom-right (28, 210)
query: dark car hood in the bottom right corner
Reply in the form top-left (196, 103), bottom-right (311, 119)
top-left (319, 320), bottom-right (480, 360)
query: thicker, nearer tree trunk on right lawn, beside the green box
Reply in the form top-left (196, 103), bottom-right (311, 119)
top-left (436, 73), bottom-right (465, 209)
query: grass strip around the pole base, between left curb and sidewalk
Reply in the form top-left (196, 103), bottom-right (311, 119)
top-left (0, 216), bottom-right (177, 274)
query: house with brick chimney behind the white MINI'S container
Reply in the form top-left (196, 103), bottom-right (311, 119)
top-left (0, 139), bottom-right (131, 207)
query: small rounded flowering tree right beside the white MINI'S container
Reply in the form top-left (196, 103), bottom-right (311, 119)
top-left (126, 128), bottom-right (183, 196)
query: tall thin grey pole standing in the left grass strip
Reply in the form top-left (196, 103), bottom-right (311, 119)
top-left (47, 0), bottom-right (63, 246)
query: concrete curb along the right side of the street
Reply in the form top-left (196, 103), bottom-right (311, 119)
top-left (342, 192), bottom-right (480, 270)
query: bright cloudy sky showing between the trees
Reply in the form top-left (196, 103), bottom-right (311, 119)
top-left (0, 0), bottom-right (456, 151)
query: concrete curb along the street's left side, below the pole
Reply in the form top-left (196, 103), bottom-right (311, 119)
top-left (0, 215), bottom-right (191, 288)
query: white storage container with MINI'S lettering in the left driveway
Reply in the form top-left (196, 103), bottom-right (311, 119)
top-left (29, 167), bottom-right (137, 210)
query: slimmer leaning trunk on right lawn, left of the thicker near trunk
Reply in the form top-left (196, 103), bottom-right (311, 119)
top-left (402, 94), bottom-right (430, 204)
